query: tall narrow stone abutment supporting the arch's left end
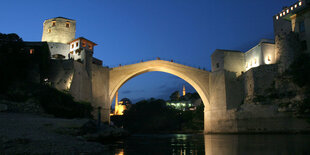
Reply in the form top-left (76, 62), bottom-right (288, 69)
top-left (92, 64), bottom-right (111, 122)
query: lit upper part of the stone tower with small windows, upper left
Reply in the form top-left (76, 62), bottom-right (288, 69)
top-left (42, 17), bottom-right (76, 44)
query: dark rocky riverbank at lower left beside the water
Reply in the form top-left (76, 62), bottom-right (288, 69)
top-left (0, 112), bottom-right (129, 154)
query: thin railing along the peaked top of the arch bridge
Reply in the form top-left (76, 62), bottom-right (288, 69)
top-left (104, 57), bottom-right (207, 70)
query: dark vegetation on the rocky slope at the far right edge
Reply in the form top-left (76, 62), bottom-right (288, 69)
top-left (255, 52), bottom-right (310, 117)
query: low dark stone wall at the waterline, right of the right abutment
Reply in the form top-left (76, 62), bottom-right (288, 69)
top-left (236, 104), bottom-right (310, 133)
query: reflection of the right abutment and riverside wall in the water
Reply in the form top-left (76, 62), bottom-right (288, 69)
top-left (204, 134), bottom-right (310, 155)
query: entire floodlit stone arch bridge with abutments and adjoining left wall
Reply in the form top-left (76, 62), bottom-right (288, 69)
top-left (49, 60), bottom-right (242, 132)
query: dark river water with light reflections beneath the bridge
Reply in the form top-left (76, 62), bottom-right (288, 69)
top-left (107, 134), bottom-right (310, 155)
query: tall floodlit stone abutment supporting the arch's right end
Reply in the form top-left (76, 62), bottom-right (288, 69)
top-left (204, 70), bottom-right (237, 133)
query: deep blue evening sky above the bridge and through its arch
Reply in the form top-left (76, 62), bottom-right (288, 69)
top-left (0, 0), bottom-right (297, 102)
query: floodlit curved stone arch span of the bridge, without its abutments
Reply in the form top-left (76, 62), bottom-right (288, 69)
top-left (109, 60), bottom-right (210, 107)
